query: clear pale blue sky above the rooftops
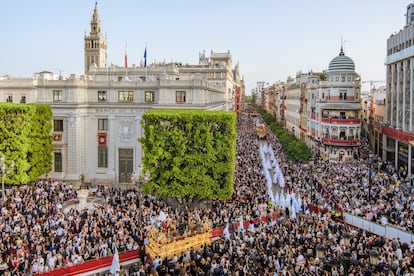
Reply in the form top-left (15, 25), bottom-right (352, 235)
top-left (0, 0), bottom-right (414, 93)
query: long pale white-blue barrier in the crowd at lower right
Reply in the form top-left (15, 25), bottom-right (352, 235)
top-left (343, 212), bottom-right (414, 243)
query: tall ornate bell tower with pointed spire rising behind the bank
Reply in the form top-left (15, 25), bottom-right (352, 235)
top-left (84, 2), bottom-right (107, 74)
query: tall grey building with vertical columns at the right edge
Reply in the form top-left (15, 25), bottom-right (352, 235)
top-left (381, 4), bottom-right (414, 175)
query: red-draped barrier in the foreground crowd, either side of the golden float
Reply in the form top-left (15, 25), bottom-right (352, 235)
top-left (33, 213), bottom-right (276, 276)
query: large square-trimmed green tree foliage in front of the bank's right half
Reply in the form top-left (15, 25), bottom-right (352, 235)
top-left (140, 110), bottom-right (237, 202)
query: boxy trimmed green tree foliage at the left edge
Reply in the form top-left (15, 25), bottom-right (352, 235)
top-left (0, 103), bottom-right (52, 184)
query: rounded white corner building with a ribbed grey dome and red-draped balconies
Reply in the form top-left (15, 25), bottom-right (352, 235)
top-left (307, 47), bottom-right (361, 161)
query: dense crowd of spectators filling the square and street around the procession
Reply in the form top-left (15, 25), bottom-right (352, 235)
top-left (0, 109), bottom-right (414, 276)
